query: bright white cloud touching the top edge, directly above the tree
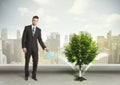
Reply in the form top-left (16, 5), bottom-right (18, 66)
top-left (69, 0), bottom-right (89, 15)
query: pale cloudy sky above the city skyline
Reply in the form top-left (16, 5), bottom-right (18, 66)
top-left (0, 0), bottom-right (120, 46)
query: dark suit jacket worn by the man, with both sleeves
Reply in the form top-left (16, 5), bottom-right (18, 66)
top-left (22, 25), bottom-right (46, 51)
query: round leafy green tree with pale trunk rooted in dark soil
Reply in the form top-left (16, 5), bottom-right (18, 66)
top-left (64, 32), bottom-right (98, 81)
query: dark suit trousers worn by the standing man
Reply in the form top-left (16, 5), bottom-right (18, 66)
top-left (25, 48), bottom-right (38, 77)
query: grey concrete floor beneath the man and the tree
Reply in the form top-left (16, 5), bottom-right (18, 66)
top-left (0, 71), bottom-right (120, 85)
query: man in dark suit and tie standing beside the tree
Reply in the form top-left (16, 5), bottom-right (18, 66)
top-left (22, 16), bottom-right (48, 81)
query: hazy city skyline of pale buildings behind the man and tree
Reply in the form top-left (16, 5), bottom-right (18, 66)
top-left (0, 29), bottom-right (120, 64)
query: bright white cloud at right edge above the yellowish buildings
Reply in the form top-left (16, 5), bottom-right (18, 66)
top-left (83, 13), bottom-right (120, 36)
